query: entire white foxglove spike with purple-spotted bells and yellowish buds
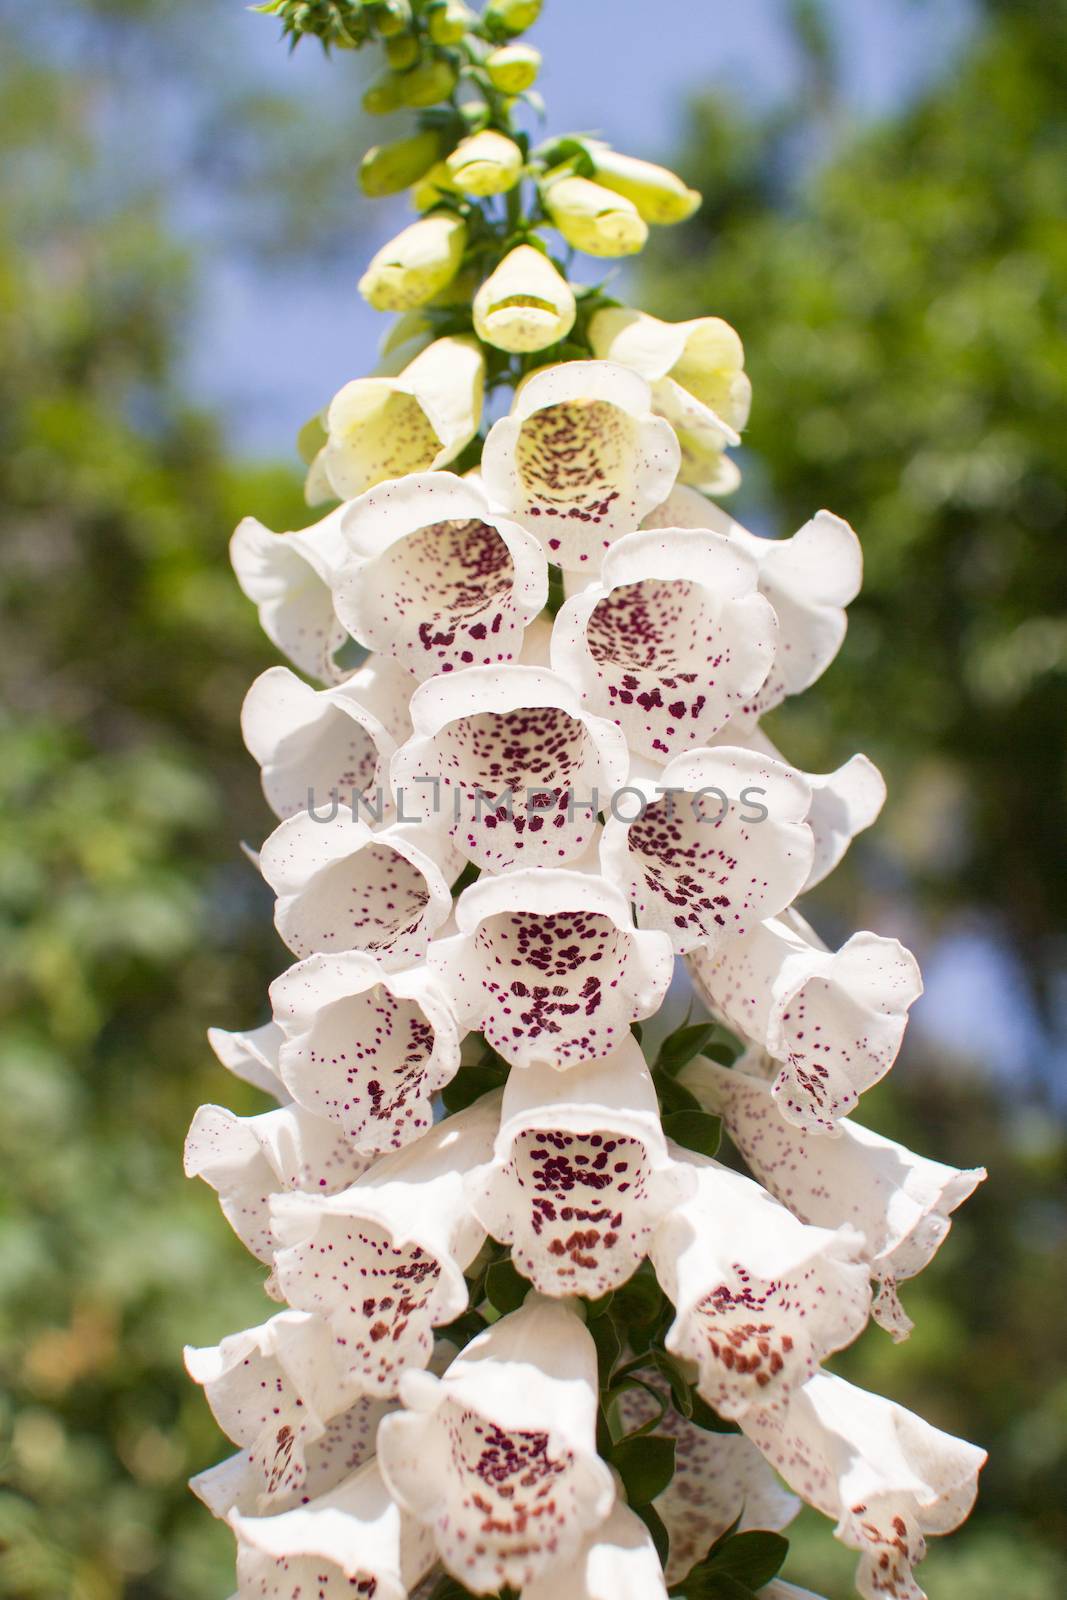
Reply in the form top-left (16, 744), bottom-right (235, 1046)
top-left (186, 3), bottom-right (984, 1600)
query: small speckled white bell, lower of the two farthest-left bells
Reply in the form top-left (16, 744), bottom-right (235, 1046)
top-left (186, 1310), bottom-right (368, 1510)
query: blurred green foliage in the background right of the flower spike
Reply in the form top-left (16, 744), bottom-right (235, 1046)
top-left (641, 0), bottom-right (1067, 1600)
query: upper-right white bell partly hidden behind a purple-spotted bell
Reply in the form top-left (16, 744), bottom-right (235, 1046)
top-left (645, 488), bottom-right (864, 723)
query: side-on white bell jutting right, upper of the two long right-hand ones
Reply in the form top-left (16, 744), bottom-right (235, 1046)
top-left (681, 1059), bottom-right (985, 1339)
